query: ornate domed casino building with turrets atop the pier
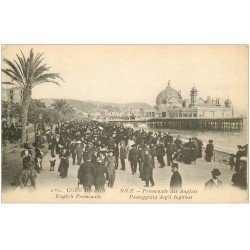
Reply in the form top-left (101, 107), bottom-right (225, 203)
top-left (142, 81), bottom-right (234, 118)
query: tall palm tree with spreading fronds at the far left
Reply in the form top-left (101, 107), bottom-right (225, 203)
top-left (2, 49), bottom-right (63, 143)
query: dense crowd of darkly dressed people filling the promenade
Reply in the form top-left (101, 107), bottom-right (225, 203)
top-left (18, 121), bottom-right (247, 191)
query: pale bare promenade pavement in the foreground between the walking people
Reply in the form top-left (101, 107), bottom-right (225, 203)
top-left (3, 145), bottom-right (247, 202)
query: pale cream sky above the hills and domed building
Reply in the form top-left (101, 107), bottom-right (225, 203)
top-left (2, 45), bottom-right (248, 113)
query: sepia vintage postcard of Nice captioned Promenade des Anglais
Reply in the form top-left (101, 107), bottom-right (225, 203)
top-left (1, 44), bottom-right (249, 203)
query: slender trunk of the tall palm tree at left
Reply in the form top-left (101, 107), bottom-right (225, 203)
top-left (21, 88), bottom-right (31, 144)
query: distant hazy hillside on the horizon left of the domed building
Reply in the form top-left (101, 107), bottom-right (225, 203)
top-left (39, 98), bottom-right (151, 112)
